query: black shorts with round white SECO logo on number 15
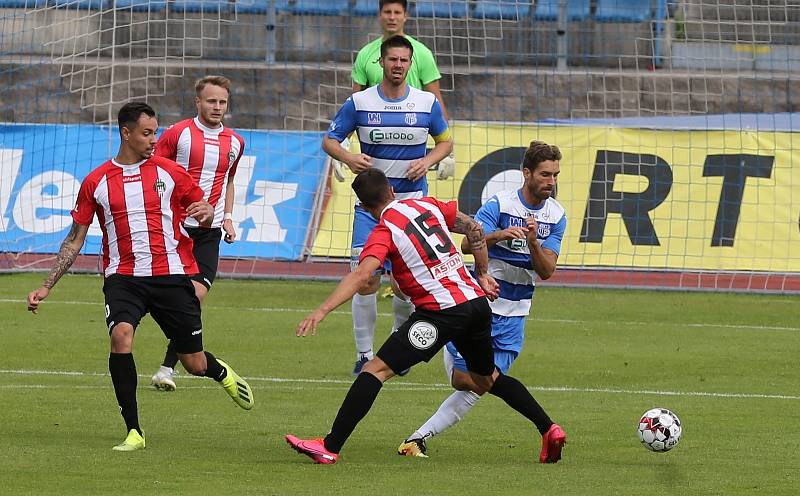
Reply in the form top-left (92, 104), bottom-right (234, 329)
top-left (377, 297), bottom-right (494, 375)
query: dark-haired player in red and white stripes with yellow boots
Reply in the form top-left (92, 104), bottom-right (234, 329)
top-left (28, 103), bottom-right (253, 451)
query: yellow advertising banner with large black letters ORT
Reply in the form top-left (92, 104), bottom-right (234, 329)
top-left (312, 123), bottom-right (800, 272)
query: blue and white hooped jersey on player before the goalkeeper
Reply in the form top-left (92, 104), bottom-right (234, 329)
top-left (328, 85), bottom-right (449, 200)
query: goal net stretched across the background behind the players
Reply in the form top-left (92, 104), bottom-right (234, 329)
top-left (0, 0), bottom-right (800, 292)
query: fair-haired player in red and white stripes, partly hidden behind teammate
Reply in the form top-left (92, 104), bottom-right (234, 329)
top-left (151, 76), bottom-right (244, 391)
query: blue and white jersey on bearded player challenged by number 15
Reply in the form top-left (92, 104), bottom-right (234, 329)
top-left (475, 190), bottom-right (567, 317)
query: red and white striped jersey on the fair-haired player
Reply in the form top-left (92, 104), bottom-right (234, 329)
top-left (155, 117), bottom-right (244, 227)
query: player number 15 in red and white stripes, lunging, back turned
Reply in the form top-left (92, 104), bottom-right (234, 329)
top-left (286, 168), bottom-right (568, 464)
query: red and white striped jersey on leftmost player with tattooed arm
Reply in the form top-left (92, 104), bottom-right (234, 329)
top-left (72, 157), bottom-right (203, 277)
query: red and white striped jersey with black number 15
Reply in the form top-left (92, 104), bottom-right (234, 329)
top-left (360, 198), bottom-right (484, 310)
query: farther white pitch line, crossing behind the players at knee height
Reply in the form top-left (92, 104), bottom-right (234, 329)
top-left (0, 298), bottom-right (800, 332)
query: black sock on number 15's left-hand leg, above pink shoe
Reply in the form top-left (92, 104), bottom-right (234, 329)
top-left (325, 372), bottom-right (383, 453)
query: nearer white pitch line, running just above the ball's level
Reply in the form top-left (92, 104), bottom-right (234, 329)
top-left (0, 369), bottom-right (800, 400)
